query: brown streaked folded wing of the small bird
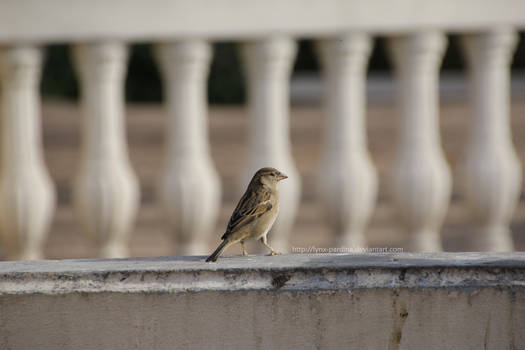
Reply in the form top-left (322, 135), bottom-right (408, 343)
top-left (222, 189), bottom-right (273, 239)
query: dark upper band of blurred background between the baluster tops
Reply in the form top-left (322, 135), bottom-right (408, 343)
top-left (41, 38), bottom-right (525, 106)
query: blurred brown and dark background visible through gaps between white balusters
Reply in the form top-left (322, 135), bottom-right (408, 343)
top-left (27, 33), bottom-right (525, 258)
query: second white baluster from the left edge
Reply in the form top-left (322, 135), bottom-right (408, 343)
top-left (74, 42), bottom-right (139, 257)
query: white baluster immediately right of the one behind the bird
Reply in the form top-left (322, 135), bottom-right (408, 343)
top-left (318, 33), bottom-right (377, 247)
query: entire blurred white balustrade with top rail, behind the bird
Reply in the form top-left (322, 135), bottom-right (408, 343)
top-left (0, 0), bottom-right (525, 259)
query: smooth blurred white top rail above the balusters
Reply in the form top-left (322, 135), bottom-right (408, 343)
top-left (0, 0), bottom-right (525, 43)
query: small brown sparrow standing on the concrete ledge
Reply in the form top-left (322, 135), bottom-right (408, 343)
top-left (206, 168), bottom-right (288, 262)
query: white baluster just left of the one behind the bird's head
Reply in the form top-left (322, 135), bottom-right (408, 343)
top-left (157, 40), bottom-right (221, 255)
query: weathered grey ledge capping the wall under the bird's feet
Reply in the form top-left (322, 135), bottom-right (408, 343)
top-left (0, 253), bottom-right (525, 294)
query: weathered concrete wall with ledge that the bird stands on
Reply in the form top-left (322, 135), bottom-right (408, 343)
top-left (0, 253), bottom-right (525, 350)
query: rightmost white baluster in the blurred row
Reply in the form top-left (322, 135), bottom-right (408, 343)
top-left (463, 29), bottom-right (521, 251)
